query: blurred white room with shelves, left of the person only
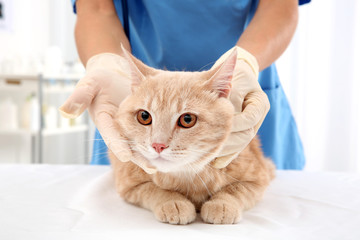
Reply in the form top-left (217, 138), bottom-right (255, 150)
top-left (0, 0), bottom-right (94, 164)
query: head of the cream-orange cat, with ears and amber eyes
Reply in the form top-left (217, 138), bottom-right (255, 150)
top-left (117, 48), bottom-right (237, 173)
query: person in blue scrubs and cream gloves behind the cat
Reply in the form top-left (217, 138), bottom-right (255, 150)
top-left (60, 0), bottom-right (310, 172)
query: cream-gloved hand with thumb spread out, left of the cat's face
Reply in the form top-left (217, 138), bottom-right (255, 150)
top-left (59, 53), bottom-right (156, 174)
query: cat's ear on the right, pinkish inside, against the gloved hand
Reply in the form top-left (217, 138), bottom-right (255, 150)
top-left (208, 49), bottom-right (237, 98)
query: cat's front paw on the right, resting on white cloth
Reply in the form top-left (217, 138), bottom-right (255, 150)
top-left (201, 200), bottom-right (242, 224)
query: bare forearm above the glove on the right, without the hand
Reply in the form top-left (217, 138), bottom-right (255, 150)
top-left (236, 0), bottom-right (298, 71)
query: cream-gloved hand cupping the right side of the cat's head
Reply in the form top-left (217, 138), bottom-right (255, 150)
top-left (212, 46), bottom-right (270, 168)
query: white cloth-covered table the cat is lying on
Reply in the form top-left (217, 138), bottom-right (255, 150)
top-left (0, 165), bottom-right (360, 240)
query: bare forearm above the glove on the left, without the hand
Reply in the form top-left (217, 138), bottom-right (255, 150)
top-left (75, 0), bottom-right (130, 66)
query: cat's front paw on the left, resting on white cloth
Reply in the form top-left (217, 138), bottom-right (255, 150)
top-left (154, 200), bottom-right (196, 224)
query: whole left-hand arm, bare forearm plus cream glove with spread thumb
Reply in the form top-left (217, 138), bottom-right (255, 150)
top-left (59, 0), bottom-right (155, 174)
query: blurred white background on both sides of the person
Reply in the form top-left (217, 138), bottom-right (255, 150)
top-left (0, 0), bottom-right (360, 173)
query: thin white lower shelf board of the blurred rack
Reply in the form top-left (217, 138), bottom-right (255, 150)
top-left (0, 124), bottom-right (88, 136)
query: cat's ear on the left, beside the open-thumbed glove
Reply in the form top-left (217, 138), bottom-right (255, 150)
top-left (121, 45), bottom-right (155, 92)
